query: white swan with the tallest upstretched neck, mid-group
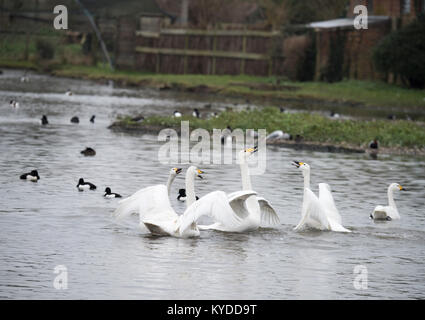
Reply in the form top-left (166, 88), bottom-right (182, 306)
top-left (199, 147), bottom-right (280, 232)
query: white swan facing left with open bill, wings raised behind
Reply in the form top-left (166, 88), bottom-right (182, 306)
top-left (292, 161), bottom-right (351, 232)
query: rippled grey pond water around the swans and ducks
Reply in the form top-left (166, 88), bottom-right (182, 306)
top-left (0, 70), bottom-right (425, 299)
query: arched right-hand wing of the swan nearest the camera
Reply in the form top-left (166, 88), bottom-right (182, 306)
top-left (180, 190), bottom-right (257, 234)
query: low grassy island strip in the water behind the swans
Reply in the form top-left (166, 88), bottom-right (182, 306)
top-left (110, 107), bottom-right (425, 149)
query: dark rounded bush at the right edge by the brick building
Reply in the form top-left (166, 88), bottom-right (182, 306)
top-left (373, 16), bottom-right (425, 88)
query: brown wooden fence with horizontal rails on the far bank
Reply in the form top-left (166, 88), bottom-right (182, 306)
top-left (135, 29), bottom-right (283, 75)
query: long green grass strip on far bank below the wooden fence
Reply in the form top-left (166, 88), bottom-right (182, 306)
top-left (49, 66), bottom-right (425, 109)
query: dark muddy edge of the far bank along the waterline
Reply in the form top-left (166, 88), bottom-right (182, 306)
top-left (3, 66), bottom-right (425, 121)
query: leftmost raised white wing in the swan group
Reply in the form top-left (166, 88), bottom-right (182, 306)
top-left (114, 184), bottom-right (176, 220)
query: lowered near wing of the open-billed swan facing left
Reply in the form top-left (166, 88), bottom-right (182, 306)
top-left (294, 189), bottom-right (329, 230)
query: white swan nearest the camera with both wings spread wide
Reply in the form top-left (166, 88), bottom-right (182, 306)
top-left (114, 166), bottom-right (256, 238)
